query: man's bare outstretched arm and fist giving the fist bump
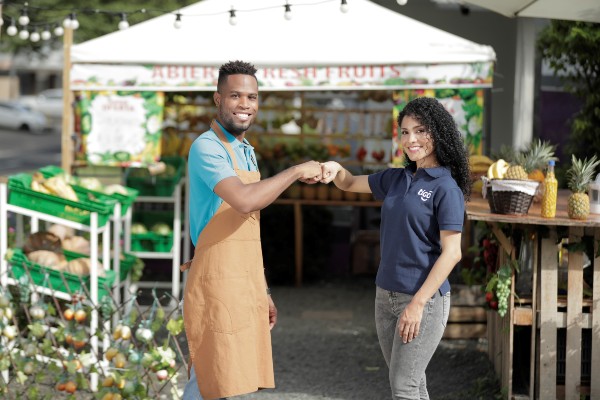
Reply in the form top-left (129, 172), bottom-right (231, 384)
top-left (214, 161), bottom-right (321, 214)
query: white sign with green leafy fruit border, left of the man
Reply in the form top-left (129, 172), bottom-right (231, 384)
top-left (76, 91), bottom-right (164, 166)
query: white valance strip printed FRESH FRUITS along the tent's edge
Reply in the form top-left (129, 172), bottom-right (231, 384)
top-left (71, 62), bottom-right (493, 91)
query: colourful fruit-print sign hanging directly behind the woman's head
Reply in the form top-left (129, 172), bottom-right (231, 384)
top-left (392, 88), bottom-right (483, 166)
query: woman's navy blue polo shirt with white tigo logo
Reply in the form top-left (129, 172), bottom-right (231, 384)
top-left (369, 167), bottom-right (465, 295)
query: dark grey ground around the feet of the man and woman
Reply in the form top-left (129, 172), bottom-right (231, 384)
top-left (182, 277), bottom-right (499, 400)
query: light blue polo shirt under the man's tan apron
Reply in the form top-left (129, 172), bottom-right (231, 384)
top-left (188, 122), bottom-right (258, 246)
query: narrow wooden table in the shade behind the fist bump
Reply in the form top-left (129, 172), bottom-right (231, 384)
top-left (274, 199), bottom-right (381, 286)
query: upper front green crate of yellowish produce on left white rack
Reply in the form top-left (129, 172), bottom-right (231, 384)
top-left (8, 173), bottom-right (116, 226)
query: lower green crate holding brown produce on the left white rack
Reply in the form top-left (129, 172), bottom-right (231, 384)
top-left (9, 249), bottom-right (116, 300)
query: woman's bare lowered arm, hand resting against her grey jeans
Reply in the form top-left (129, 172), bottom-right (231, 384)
top-left (398, 231), bottom-right (462, 343)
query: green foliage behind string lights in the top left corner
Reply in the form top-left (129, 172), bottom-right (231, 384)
top-left (0, 0), bottom-right (197, 53)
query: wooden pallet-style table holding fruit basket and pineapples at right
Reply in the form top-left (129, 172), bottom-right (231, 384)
top-left (466, 191), bottom-right (600, 399)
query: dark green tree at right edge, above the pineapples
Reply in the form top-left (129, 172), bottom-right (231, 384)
top-left (538, 20), bottom-right (600, 162)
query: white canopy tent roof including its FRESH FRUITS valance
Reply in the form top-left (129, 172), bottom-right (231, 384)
top-left (71, 0), bottom-right (495, 90)
